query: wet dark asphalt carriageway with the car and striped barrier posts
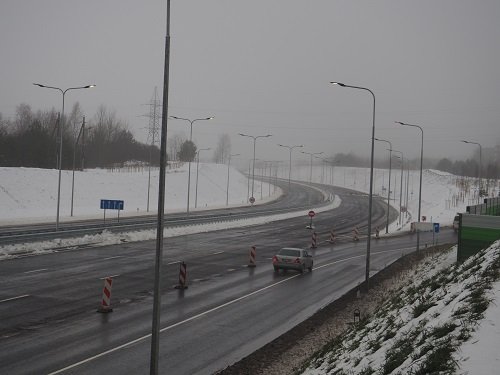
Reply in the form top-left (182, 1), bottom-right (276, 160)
top-left (0, 184), bottom-right (456, 374)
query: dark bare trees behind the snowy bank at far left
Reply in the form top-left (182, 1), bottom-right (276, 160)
top-left (0, 103), bottom-right (160, 169)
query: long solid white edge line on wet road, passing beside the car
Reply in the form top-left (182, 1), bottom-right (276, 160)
top-left (48, 249), bottom-right (410, 375)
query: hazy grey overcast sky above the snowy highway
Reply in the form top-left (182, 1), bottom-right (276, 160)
top-left (0, 0), bottom-right (500, 166)
